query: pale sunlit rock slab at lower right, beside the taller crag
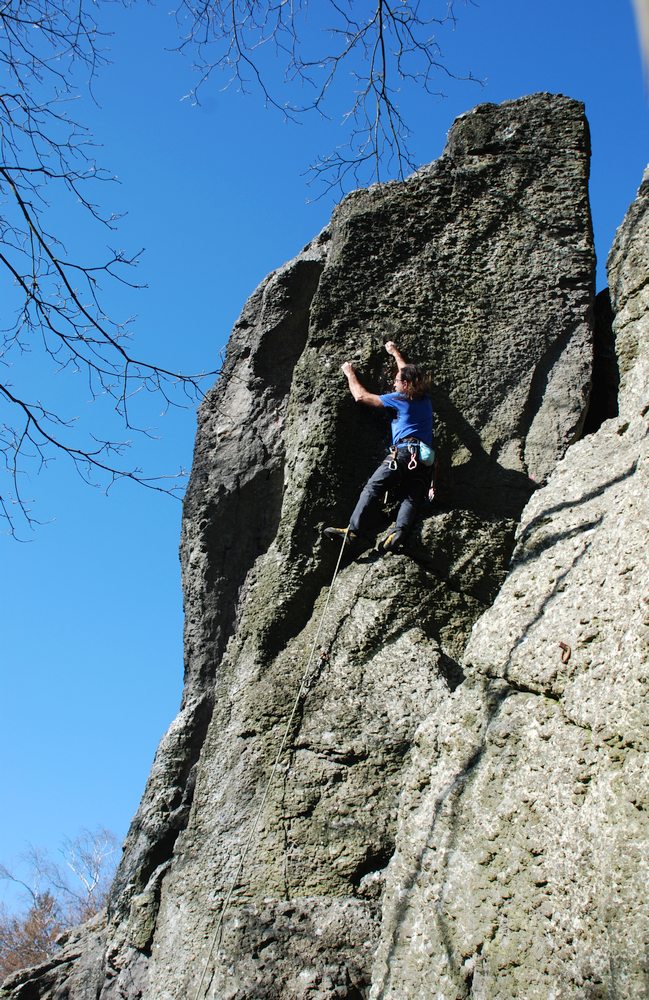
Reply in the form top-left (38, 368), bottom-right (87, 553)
top-left (371, 170), bottom-right (649, 1000)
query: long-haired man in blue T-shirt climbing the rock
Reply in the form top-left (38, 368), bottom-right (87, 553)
top-left (325, 340), bottom-right (434, 552)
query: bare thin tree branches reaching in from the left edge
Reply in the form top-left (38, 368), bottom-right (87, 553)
top-left (0, 0), bottom-right (214, 534)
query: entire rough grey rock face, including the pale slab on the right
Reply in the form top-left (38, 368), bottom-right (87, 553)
top-left (2, 95), bottom-right (649, 1000)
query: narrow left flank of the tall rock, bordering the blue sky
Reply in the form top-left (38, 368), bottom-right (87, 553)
top-left (110, 234), bottom-right (327, 918)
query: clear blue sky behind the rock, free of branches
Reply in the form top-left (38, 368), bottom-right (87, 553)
top-left (0, 0), bottom-right (649, 898)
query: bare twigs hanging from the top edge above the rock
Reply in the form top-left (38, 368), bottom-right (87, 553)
top-left (176, 0), bottom-right (473, 192)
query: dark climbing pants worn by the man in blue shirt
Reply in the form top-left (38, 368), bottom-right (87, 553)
top-left (349, 448), bottom-right (432, 534)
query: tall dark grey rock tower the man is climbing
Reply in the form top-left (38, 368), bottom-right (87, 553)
top-left (0, 94), bottom-right (594, 1000)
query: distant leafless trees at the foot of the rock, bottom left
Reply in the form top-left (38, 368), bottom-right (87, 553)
top-left (0, 829), bottom-right (118, 983)
